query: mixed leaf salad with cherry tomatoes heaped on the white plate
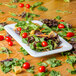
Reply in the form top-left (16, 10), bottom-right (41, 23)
top-left (14, 21), bottom-right (61, 52)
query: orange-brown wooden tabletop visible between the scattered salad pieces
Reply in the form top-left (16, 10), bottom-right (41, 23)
top-left (0, 0), bottom-right (76, 76)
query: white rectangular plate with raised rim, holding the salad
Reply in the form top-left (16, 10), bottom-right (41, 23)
top-left (4, 20), bottom-right (72, 57)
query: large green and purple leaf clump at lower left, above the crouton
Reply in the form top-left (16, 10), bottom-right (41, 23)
top-left (0, 58), bottom-right (26, 73)
